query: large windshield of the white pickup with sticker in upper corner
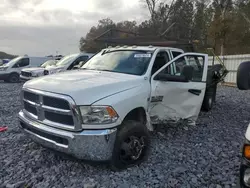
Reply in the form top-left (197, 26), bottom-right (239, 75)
top-left (81, 50), bottom-right (152, 75)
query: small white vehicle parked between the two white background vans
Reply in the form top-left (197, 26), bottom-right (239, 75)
top-left (20, 60), bottom-right (58, 81)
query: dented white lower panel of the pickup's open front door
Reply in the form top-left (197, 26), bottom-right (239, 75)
top-left (149, 81), bottom-right (206, 124)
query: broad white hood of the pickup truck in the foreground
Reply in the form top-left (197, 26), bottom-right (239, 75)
top-left (24, 70), bottom-right (144, 105)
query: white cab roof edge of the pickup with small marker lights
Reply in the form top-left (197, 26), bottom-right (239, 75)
top-left (104, 45), bottom-right (184, 52)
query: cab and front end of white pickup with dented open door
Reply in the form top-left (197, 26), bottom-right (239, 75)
top-left (19, 46), bottom-right (227, 169)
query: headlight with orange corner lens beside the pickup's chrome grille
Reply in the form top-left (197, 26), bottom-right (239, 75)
top-left (80, 106), bottom-right (119, 124)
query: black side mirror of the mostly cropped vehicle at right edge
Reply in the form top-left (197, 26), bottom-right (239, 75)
top-left (237, 61), bottom-right (250, 90)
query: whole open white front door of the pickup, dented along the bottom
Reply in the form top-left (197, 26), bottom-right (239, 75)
top-left (149, 53), bottom-right (208, 123)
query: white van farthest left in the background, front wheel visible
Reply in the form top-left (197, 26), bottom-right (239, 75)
top-left (0, 55), bottom-right (53, 82)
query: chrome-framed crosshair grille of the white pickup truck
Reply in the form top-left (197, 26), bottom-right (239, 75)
top-left (22, 89), bottom-right (81, 131)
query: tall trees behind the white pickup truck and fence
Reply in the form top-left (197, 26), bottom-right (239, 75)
top-left (79, 0), bottom-right (250, 54)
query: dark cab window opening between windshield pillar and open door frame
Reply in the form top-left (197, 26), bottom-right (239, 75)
top-left (151, 51), bottom-right (171, 75)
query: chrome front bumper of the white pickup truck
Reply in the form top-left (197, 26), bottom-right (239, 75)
top-left (18, 111), bottom-right (117, 161)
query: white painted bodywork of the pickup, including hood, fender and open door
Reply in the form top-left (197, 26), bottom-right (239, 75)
top-left (24, 47), bottom-right (208, 129)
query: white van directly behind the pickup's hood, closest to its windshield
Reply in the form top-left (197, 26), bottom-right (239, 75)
top-left (44, 53), bottom-right (94, 75)
